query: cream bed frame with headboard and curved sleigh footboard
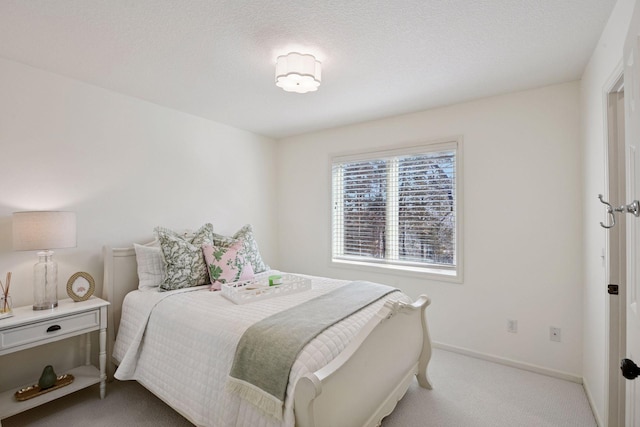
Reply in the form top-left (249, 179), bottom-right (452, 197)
top-left (103, 247), bottom-right (431, 427)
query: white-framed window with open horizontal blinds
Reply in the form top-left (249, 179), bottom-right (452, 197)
top-left (331, 140), bottom-right (461, 279)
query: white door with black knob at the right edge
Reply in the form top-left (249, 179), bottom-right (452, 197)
top-left (623, 4), bottom-right (640, 427)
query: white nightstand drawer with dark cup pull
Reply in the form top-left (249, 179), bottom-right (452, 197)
top-left (0, 310), bottom-right (100, 350)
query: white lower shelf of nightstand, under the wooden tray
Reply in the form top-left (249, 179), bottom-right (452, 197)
top-left (0, 365), bottom-right (100, 419)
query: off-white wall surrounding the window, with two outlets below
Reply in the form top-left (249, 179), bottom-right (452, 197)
top-left (278, 82), bottom-right (582, 377)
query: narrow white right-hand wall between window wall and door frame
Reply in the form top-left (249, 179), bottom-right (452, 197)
top-left (580, 0), bottom-right (636, 425)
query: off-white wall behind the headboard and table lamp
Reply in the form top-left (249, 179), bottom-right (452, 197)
top-left (0, 59), bottom-right (277, 389)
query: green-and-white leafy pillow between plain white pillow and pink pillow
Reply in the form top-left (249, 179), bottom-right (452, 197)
top-left (154, 224), bottom-right (213, 291)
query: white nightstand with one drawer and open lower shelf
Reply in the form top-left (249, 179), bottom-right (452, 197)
top-left (0, 297), bottom-right (109, 426)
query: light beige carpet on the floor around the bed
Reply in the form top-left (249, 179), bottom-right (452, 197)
top-left (2, 349), bottom-right (596, 427)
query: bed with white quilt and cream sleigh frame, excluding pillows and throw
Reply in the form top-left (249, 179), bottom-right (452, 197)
top-left (103, 242), bottom-right (431, 427)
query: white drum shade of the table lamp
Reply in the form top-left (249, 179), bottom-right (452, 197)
top-left (13, 211), bottom-right (76, 251)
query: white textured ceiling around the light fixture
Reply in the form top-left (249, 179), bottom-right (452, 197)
top-left (0, 0), bottom-right (615, 138)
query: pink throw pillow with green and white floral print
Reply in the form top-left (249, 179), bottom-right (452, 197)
top-left (202, 241), bottom-right (253, 291)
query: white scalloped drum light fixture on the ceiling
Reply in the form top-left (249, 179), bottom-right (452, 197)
top-left (276, 52), bottom-right (322, 93)
